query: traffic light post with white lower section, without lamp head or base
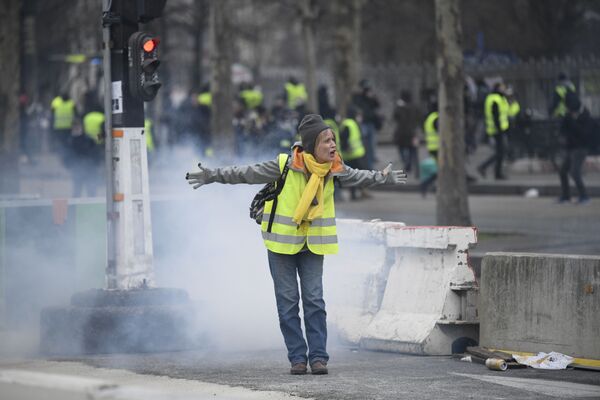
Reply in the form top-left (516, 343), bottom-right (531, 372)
top-left (103, 0), bottom-right (154, 289)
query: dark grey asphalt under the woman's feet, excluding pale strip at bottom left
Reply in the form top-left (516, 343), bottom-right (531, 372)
top-left (74, 347), bottom-right (600, 400)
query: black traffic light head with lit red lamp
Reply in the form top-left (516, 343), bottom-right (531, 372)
top-left (128, 32), bottom-right (162, 101)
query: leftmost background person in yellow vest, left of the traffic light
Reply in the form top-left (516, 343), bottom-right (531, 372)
top-left (50, 92), bottom-right (76, 164)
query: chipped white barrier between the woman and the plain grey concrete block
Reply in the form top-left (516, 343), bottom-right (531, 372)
top-left (330, 221), bottom-right (478, 355)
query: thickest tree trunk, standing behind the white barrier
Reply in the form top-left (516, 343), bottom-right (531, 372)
top-left (435, 0), bottom-right (471, 226)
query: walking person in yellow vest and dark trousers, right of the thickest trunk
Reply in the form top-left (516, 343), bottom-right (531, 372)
top-left (477, 83), bottom-right (510, 180)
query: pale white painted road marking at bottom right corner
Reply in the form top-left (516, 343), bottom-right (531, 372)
top-left (450, 372), bottom-right (600, 398)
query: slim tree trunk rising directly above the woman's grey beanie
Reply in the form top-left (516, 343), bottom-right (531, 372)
top-left (300, 0), bottom-right (319, 113)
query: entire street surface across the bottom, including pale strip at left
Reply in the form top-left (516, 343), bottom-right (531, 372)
top-left (0, 347), bottom-right (600, 400)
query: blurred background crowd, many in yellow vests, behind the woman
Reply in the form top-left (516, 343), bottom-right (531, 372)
top-left (20, 74), bottom-right (598, 200)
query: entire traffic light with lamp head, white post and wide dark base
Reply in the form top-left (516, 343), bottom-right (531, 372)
top-left (39, 0), bottom-right (196, 355)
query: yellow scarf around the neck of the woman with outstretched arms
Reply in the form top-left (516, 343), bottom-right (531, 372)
top-left (292, 153), bottom-right (331, 225)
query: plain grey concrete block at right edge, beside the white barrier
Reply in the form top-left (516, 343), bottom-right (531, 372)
top-left (479, 253), bottom-right (600, 360)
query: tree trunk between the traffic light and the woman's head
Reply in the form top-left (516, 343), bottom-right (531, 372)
top-left (210, 0), bottom-right (235, 158)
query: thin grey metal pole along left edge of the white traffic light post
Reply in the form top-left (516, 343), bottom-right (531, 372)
top-left (102, 0), bottom-right (116, 289)
